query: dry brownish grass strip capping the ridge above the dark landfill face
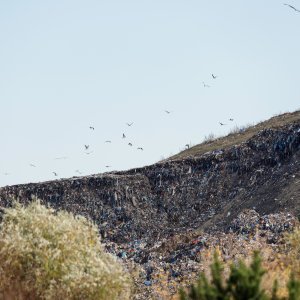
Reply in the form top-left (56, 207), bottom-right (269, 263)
top-left (168, 110), bottom-right (300, 160)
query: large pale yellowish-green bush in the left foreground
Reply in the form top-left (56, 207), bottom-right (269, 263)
top-left (0, 201), bottom-right (130, 300)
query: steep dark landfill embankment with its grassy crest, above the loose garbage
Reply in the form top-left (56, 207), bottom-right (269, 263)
top-left (0, 112), bottom-right (300, 243)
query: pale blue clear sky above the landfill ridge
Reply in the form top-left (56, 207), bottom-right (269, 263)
top-left (0, 0), bottom-right (300, 187)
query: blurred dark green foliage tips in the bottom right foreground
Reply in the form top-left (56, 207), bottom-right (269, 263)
top-left (179, 252), bottom-right (300, 300)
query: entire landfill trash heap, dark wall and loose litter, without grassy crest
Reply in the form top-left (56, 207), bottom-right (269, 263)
top-left (0, 117), bottom-right (300, 299)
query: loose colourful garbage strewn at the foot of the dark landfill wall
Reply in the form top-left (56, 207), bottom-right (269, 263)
top-left (106, 210), bottom-right (299, 299)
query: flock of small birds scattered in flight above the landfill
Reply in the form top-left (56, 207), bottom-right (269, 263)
top-left (3, 3), bottom-right (300, 177)
